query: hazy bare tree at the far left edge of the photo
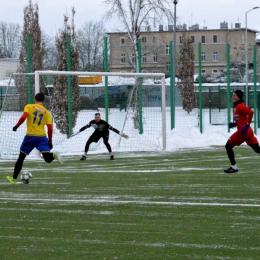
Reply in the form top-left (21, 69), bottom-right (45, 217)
top-left (0, 22), bottom-right (21, 58)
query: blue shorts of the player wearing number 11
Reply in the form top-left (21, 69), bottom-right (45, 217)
top-left (20, 135), bottom-right (50, 154)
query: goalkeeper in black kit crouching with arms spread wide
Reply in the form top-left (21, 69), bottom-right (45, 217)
top-left (71, 113), bottom-right (128, 161)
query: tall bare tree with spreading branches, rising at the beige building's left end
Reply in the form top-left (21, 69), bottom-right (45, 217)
top-left (104, 0), bottom-right (174, 128)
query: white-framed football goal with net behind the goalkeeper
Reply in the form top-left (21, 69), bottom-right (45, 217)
top-left (0, 71), bottom-right (166, 158)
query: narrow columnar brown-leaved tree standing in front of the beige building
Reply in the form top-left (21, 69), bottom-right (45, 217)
top-left (177, 32), bottom-right (194, 113)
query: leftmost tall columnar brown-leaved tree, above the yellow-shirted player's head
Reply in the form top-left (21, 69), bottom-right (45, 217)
top-left (15, 0), bottom-right (45, 107)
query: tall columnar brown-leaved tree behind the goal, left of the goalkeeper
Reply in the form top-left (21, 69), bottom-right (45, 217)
top-left (52, 8), bottom-right (80, 134)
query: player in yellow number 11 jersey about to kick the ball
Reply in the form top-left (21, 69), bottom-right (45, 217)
top-left (6, 93), bottom-right (63, 184)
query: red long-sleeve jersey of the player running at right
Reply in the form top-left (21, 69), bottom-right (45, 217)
top-left (234, 103), bottom-right (254, 131)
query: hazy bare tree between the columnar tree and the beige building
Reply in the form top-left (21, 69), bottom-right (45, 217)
top-left (77, 21), bottom-right (105, 71)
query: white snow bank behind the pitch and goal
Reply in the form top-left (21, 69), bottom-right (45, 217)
top-left (0, 104), bottom-right (250, 158)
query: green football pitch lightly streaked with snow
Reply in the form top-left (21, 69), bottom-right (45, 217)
top-left (0, 146), bottom-right (260, 260)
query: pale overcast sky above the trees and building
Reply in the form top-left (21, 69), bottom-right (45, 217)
top-left (0, 0), bottom-right (260, 38)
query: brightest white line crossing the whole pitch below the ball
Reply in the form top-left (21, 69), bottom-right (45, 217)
top-left (0, 198), bottom-right (260, 208)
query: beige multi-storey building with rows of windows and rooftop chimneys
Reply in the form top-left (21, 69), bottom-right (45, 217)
top-left (109, 22), bottom-right (257, 76)
